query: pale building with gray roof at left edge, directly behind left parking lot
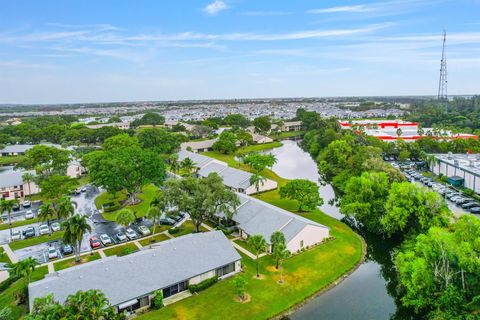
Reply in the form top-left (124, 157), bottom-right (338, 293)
top-left (0, 170), bottom-right (40, 199)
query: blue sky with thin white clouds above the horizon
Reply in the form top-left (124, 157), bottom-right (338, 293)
top-left (0, 0), bottom-right (480, 103)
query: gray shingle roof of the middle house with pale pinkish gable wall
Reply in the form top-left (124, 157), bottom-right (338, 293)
top-left (222, 193), bottom-right (328, 243)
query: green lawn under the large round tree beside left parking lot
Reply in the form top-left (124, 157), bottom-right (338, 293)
top-left (95, 184), bottom-right (158, 221)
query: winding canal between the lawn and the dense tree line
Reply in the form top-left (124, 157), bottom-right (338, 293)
top-left (262, 141), bottom-right (411, 320)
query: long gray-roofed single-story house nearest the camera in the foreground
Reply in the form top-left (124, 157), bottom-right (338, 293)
top-left (28, 231), bottom-right (241, 311)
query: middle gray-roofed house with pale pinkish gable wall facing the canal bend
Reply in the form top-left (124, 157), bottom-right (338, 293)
top-left (220, 193), bottom-right (330, 253)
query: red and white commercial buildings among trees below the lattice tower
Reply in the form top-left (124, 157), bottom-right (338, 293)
top-left (339, 119), bottom-right (478, 142)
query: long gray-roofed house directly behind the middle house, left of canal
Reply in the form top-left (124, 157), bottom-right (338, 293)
top-left (178, 151), bottom-right (278, 194)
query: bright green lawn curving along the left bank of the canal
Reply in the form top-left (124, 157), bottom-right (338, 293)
top-left (138, 144), bottom-right (362, 320)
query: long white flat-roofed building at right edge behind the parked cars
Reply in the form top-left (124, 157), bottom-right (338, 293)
top-left (430, 153), bottom-right (480, 194)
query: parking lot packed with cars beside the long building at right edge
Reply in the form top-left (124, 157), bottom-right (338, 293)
top-left (392, 162), bottom-right (480, 217)
